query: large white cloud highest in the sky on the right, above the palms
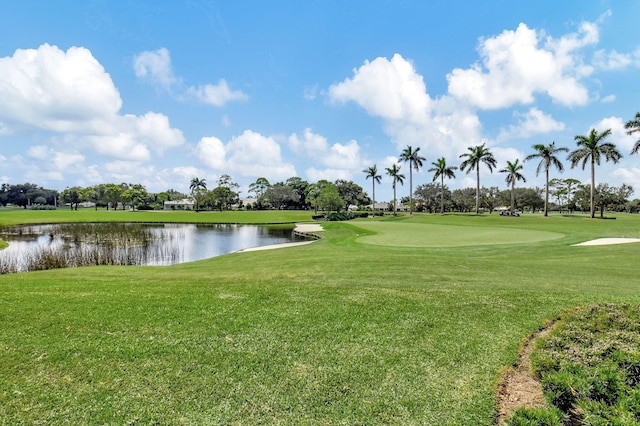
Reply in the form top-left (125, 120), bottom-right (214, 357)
top-left (447, 23), bottom-right (598, 109)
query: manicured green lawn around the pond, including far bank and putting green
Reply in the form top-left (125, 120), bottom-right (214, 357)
top-left (0, 210), bottom-right (640, 425)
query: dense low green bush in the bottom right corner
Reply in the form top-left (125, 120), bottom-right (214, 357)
top-left (524, 304), bottom-right (640, 425)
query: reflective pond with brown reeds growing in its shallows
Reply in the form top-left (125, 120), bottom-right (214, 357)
top-left (0, 223), bottom-right (304, 273)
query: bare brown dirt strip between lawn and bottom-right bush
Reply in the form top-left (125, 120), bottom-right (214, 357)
top-left (496, 320), bottom-right (557, 425)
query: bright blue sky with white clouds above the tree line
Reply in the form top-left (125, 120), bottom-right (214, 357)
top-left (0, 0), bottom-right (640, 201)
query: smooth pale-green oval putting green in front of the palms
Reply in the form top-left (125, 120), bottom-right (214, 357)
top-left (358, 222), bottom-right (564, 247)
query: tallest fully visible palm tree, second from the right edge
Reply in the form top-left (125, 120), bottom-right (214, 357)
top-left (567, 129), bottom-right (622, 219)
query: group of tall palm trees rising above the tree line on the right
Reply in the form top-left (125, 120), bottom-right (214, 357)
top-left (363, 112), bottom-right (640, 218)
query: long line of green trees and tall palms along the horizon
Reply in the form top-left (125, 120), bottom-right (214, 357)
top-left (5, 112), bottom-right (640, 217)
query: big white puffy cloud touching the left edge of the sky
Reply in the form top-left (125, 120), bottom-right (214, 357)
top-left (0, 44), bottom-right (122, 132)
